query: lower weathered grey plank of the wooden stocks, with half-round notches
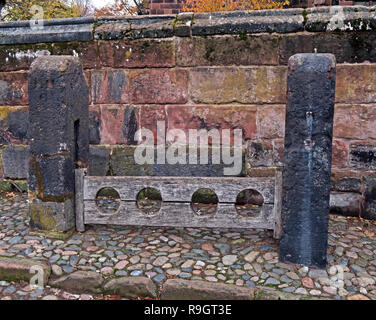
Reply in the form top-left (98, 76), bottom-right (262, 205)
top-left (85, 200), bottom-right (274, 230)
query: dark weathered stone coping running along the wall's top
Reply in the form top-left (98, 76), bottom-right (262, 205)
top-left (0, 6), bottom-right (376, 45)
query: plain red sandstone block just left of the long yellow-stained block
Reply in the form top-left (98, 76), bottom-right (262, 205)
top-left (129, 69), bottom-right (188, 104)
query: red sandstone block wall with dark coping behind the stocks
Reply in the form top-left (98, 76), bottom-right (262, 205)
top-left (0, 6), bottom-right (376, 218)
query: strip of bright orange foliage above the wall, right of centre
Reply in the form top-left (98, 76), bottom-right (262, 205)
top-left (183, 0), bottom-right (290, 12)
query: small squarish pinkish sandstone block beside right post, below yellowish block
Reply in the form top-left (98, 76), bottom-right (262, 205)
top-left (257, 105), bottom-right (286, 139)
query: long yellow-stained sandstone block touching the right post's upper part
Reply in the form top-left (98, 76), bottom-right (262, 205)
top-left (189, 67), bottom-right (287, 104)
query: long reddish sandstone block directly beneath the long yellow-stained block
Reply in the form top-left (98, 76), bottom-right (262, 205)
top-left (166, 105), bottom-right (257, 144)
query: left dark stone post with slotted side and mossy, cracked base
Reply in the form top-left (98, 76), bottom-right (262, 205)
top-left (29, 56), bottom-right (89, 236)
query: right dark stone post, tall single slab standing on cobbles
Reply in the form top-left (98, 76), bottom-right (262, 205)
top-left (280, 54), bottom-right (336, 268)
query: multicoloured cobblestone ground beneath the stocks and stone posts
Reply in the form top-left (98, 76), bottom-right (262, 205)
top-left (0, 196), bottom-right (376, 300)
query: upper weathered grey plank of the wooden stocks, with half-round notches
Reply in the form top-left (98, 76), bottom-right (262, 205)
top-left (84, 176), bottom-right (275, 204)
